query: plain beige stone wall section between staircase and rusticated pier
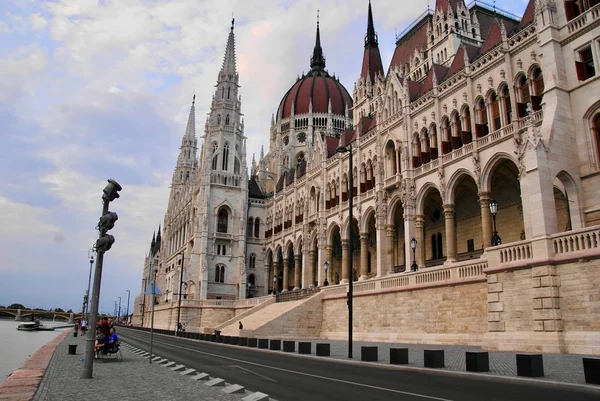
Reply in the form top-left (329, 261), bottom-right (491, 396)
top-left (321, 282), bottom-right (487, 345)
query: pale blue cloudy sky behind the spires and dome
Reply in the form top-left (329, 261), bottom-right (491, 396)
top-left (0, 0), bottom-right (526, 313)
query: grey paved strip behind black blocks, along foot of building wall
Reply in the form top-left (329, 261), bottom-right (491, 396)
top-left (296, 340), bottom-right (598, 384)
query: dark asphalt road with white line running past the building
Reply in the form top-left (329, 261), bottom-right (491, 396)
top-left (119, 327), bottom-right (600, 401)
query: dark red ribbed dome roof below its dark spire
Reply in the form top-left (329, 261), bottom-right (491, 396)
top-left (277, 70), bottom-right (352, 120)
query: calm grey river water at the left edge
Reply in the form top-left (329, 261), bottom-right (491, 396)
top-left (0, 320), bottom-right (72, 383)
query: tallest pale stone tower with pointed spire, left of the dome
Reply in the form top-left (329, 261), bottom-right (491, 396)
top-left (191, 20), bottom-right (248, 299)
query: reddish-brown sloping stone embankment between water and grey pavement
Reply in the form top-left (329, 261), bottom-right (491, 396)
top-left (0, 331), bottom-right (71, 401)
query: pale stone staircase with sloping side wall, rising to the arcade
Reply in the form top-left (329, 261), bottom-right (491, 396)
top-left (221, 292), bottom-right (324, 339)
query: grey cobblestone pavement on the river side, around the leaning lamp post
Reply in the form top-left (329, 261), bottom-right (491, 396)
top-left (32, 336), bottom-right (268, 401)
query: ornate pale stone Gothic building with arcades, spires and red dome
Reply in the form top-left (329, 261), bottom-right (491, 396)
top-left (136, 0), bottom-right (600, 353)
